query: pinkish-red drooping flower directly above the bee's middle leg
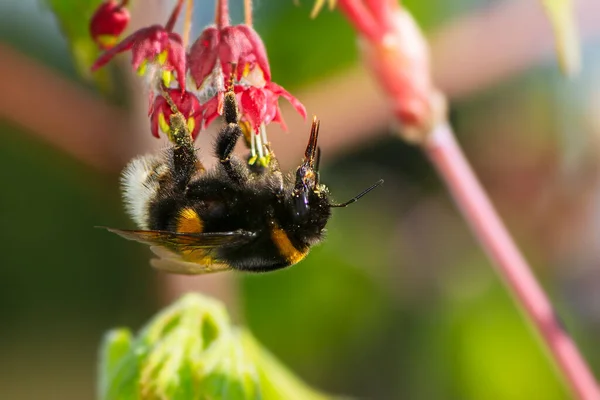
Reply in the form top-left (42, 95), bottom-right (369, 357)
top-left (188, 25), bottom-right (271, 87)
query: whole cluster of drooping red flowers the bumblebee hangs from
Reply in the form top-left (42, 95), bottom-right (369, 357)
top-left (90, 0), bottom-right (306, 161)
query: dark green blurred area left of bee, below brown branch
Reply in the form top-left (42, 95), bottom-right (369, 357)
top-left (0, 119), bottom-right (158, 400)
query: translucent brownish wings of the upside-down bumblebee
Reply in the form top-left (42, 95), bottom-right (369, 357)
top-left (105, 228), bottom-right (256, 275)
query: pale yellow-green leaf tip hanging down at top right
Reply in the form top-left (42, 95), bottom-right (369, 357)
top-left (541, 0), bottom-right (581, 76)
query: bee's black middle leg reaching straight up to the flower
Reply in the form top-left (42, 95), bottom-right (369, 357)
top-left (215, 91), bottom-right (248, 183)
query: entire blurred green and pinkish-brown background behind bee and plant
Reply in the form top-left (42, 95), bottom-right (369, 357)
top-left (0, 0), bottom-right (600, 400)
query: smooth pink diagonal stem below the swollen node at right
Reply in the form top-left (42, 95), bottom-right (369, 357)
top-left (423, 124), bottom-right (600, 400)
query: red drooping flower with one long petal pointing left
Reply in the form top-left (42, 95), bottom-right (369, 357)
top-left (92, 25), bottom-right (186, 90)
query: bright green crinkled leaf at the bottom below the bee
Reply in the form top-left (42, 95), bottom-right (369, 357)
top-left (99, 294), bottom-right (328, 400)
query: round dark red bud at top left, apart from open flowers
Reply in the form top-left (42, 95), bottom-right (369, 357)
top-left (90, 0), bottom-right (129, 50)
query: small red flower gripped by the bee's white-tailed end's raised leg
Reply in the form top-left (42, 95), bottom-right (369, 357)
top-left (150, 89), bottom-right (202, 139)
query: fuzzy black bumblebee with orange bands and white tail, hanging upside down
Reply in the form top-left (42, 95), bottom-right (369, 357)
top-left (107, 90), bottom-right (383, 275)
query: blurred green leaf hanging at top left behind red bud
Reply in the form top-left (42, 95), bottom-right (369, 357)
top-left (42, 0), bottom-right (112, 91)
